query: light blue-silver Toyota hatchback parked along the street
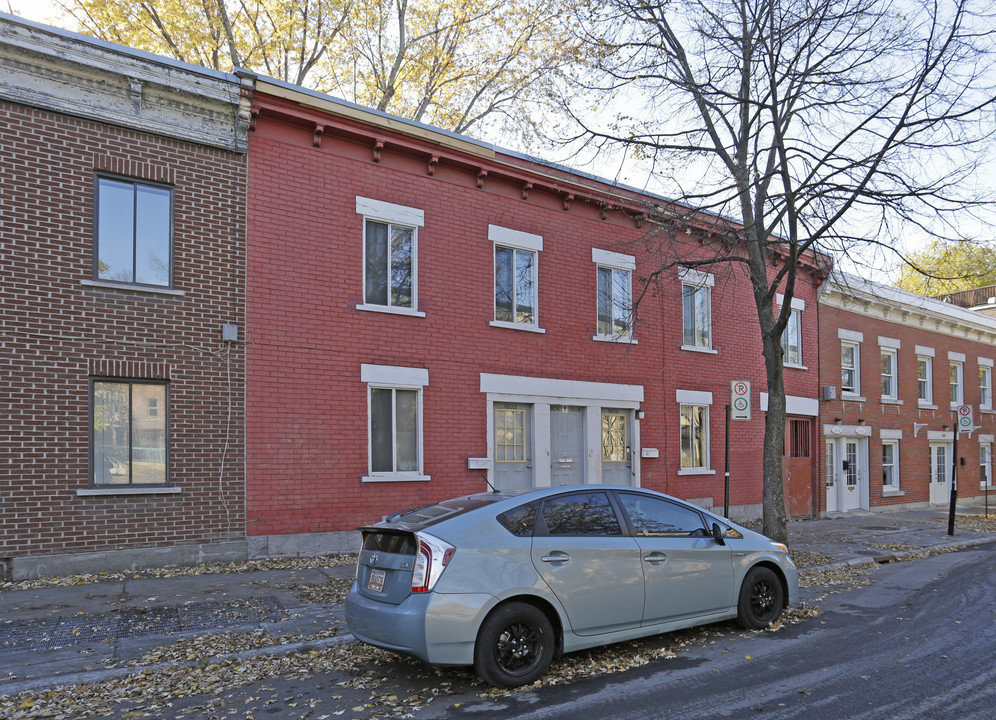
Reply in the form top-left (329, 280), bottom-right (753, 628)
top-left (346, 485), bottom-right (799, 687)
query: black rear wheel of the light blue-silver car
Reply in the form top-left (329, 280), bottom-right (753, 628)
top-left (474, 603), bottom-right (554, 687)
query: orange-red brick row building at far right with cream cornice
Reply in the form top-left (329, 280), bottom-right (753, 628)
top-left (820, 277), bottom-right (996, 512)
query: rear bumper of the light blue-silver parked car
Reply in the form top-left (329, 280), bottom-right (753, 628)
top-left (345, 583), bottom-right (496, 665)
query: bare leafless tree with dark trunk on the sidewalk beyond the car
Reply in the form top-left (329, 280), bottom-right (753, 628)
top-left (567, 0), bottom-right (996, 541)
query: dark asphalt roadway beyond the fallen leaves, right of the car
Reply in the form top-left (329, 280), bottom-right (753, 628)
top-left (430, 545), bottom-right (996, 720)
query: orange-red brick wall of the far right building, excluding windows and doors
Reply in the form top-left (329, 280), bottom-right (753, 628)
top-left (820, 305), bottom-right (996, 508)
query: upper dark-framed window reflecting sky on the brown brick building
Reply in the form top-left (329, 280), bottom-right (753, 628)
top-left (94, 177), bottom-right (173, 287)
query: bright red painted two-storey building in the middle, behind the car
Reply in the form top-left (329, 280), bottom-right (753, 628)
top-left (247, 79), bottom-right (819, 554)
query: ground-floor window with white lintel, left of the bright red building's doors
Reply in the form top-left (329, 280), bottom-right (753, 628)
top-left (361, 365), bottom-right (429, 482)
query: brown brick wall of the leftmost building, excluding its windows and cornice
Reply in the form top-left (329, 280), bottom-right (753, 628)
top-left (0, 102), bottom-right (245, 557)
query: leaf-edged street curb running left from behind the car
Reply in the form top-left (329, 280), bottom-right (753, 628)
top-left (0, 633), bottom-right (356, 697)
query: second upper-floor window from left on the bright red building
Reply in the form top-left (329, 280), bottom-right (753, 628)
top-left (488, 225), bottom-right (543, 330)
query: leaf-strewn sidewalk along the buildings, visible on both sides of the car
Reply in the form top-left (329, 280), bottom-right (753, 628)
top-left (0, 508), bottom-right (996, 696)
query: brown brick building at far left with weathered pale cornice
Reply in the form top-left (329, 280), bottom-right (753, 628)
top-left (0, 16), bottom-right (248, 578)
